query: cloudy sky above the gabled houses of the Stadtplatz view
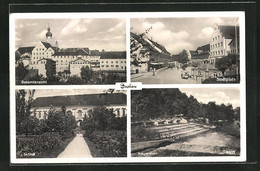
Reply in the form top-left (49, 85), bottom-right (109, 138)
top-left (131, 17), bottom-right (237, 54)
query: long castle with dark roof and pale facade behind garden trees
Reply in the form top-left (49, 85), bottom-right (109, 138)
top-left (31, 93), bottom-right (126, 121)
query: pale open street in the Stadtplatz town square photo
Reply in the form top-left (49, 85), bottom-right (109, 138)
top-left (131, 67), bottom-right (196, 84)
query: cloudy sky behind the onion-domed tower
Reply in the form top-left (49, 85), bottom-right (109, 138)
top-left (15, 18), bottom-right (126, 51)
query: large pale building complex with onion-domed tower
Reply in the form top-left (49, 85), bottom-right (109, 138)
top-left (16, 27), bottom-right (126, 77)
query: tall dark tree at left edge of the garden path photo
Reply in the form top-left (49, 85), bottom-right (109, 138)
top-left (16, 89), bottom-right (35, 137)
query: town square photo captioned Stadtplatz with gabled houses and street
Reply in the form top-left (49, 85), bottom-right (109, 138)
top-left (130, 16), bottom-right (240, 84)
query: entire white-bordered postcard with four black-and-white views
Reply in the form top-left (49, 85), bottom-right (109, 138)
top-left (9, 11), bottom-right (247, 164)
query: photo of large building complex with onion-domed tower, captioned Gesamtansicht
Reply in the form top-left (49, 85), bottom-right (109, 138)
top-left (10, 15), bottom-right (126, 85)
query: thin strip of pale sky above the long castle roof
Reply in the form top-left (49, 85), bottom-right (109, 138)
top-left (33, 89), bottom-right (126, 99)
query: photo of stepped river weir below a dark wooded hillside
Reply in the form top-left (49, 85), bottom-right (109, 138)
top-left (131, 87), bottom-right (241, 157)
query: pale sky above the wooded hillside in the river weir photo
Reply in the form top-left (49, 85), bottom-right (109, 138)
top-left (180, 87), bottom-right (240, 108)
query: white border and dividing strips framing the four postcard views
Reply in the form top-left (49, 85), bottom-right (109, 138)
top-left (9, 11), bottom-right (246, 164)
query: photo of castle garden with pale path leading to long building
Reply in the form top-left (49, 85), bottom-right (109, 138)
top-left (14, 89), bottom-right (127, 159)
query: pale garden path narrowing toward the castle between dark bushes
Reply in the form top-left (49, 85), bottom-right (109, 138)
top-left (58, 134), bottom-right (92, 158)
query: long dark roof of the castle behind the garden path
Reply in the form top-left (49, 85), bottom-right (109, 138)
top-left (32, 93), bottom-right (126, 107)
